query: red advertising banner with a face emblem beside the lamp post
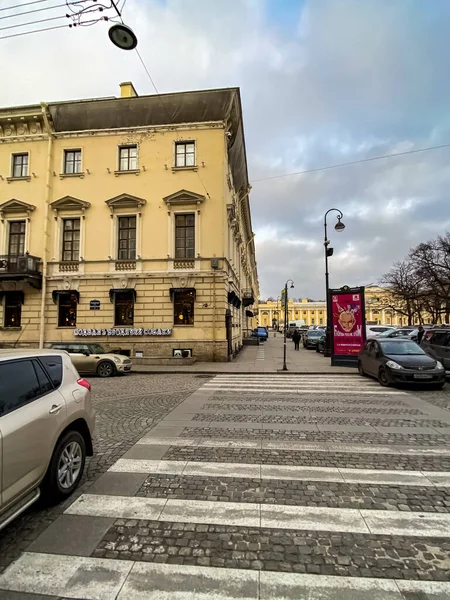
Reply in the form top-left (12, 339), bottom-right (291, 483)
top-left (331, 293), bottom-right (365, 356)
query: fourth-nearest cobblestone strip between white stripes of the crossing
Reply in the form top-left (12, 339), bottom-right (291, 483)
top-left (180, 427), bottom-right (448, 446)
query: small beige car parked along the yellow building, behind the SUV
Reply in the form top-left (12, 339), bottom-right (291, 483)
top-left (51, 342), bottom-right (132, 377)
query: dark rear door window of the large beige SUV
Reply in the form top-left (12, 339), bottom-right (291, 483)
top-left (0, 360), bottom-right (42, 415)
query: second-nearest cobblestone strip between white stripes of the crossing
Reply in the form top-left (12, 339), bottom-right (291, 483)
top-left (136, 475), bottom-right (450, 513)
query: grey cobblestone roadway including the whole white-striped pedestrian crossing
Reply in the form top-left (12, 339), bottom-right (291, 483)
top-left (0, 375), bottom-right (450, 600)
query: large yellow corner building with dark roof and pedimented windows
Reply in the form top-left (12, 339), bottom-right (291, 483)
top-left (0, 83), bottom-right (258, 360)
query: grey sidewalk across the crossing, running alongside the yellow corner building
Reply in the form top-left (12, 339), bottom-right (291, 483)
top-left (133, 331), bottom-right (356, 375)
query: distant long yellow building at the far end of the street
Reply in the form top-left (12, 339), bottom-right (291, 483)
top-left (258, 285), bottom-right (418, 327)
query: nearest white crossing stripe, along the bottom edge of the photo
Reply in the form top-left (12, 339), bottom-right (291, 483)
top-left (0, 552), bottom-right (450, 600)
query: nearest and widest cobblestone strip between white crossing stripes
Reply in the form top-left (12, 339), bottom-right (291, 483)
top-left (92, 519), bottom-right (450, 581)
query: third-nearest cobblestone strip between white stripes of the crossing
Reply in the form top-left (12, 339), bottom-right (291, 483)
top-left (163, 446), bottom-right (450, 471)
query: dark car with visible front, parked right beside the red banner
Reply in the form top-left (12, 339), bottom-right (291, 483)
top-left (358, 338), bottom-right (445, 388)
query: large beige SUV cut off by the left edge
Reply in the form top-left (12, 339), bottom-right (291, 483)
top-left (0, 350), bottom-right (95, 529)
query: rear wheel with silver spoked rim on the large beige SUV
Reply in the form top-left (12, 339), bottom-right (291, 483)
top-left (43, 431), bottom-right (86, 503)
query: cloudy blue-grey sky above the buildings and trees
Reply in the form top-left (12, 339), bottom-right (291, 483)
top-left (0, 0), bottom-right (450, 299)
